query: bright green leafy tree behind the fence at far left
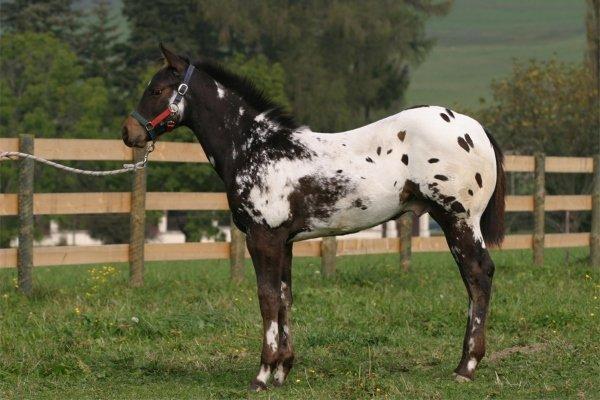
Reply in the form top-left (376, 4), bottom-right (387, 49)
top-left (0, 32), bottom-right (116, 246)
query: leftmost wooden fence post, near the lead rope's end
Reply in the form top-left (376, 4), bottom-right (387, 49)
top-left (17, 135), bottom-right (34, 295)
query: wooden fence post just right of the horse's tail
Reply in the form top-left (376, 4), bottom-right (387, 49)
top-left (533, 153), bottom-right (546, 266)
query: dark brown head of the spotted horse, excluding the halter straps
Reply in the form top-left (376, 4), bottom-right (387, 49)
top-left (121, 44), bottom-right (189, 147)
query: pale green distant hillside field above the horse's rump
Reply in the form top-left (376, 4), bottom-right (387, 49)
top-left (407, 0), bottom-right (585, 107)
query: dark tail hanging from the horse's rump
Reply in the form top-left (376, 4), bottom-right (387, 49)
top-left (480, 129), bottom-right (506, 246)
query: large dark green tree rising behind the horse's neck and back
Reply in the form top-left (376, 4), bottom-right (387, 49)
top-left (124, 0), bottom-right (450, 130)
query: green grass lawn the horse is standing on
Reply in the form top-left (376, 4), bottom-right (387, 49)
top-left (0, 249), bottom-right (600, 399)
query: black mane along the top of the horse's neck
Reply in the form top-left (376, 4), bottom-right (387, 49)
top-left (194, 61), bottom-right (299, 129)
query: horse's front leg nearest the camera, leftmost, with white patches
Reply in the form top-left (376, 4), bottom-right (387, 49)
top-left (246, 229), bottom-right (287, 391)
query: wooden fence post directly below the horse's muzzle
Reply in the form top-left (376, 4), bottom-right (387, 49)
top-left (129, 148), bottom-right (146, 287)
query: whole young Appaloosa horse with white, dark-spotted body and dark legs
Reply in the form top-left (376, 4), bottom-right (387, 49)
top-left (122, 45), bottom-right (505, 390)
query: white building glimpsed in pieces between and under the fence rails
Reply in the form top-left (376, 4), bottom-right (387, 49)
top-left (10, 213), bottom-right (431, 247)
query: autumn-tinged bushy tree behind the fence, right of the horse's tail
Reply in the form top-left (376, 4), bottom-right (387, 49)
top-left (478, 60), bottom-right (600, 233)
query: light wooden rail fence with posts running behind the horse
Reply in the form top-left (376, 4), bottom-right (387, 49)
top-left (0, 135), bottom-right (600, 292)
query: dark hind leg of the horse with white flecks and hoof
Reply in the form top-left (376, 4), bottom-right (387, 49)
top-left (428, 209), bottom-right (494, 382)
